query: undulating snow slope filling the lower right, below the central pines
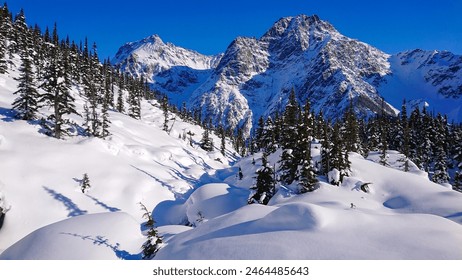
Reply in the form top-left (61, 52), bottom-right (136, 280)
top-left (157, 149), bottom-right (462, 259)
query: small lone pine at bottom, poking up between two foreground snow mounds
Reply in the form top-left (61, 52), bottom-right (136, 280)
top-left (140, 202), bottom-right (163, 260)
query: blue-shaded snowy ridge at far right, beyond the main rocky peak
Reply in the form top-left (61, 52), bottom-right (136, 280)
top-left (378, 50), bottom-right (462, 122)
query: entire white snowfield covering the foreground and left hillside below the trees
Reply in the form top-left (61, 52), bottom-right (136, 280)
top-left (0, 64), bottom-right (462, 260)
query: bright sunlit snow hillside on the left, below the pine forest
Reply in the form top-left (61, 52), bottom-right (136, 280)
top-left (0, 64), bottom-right (234, 259)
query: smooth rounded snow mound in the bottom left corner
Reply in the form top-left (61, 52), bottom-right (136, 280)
top-left (0, 212), bottom-right (144, 260)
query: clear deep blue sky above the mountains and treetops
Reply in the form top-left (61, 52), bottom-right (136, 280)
top-left (7, 0), bottom-right (462, 58)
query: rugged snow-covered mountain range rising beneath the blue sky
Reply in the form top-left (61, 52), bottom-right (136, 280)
top-left (112, 15), bottom-right (462, 136)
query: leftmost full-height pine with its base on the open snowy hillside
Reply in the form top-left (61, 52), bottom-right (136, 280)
top-left (12, 45), bottom-right (39, 120)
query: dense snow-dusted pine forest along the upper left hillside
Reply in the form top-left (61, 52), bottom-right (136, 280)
top-left (0, 4), bottom-right (158, 139)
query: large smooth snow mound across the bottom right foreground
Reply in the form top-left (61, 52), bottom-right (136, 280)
top-left (156, 199), bottom-right (462, 259)
